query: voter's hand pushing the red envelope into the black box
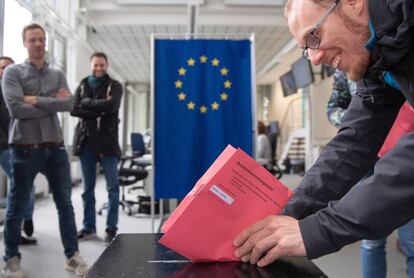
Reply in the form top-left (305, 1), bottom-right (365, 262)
top-left (233, 215), bottom-right (306, 267)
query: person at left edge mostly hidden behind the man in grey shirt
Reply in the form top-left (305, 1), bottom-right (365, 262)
top-left (0, 56), bottom-right (37, 245)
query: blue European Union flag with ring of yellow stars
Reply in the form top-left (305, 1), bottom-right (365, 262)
top-left (154, 39), bottom-right (253, 199)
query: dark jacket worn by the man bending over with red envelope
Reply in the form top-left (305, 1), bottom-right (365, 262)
top-left (284, 0), bottom-right (414, 258)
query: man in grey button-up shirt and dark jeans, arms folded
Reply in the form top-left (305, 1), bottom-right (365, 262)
top-left (2, 23), bottom-right (88, 278)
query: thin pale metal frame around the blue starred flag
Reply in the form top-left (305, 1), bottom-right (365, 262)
top-left (147, 33), bottom-right (258, 233)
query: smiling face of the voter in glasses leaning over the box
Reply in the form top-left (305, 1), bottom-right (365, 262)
top-left (286, 0), bottom-right (370, 80)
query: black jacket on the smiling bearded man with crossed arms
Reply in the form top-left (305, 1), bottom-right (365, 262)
top-left (71, 75), bottom-right (122, 157)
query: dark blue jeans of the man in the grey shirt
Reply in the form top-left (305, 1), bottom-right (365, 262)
top-left (4, 146), bottom-right (78, 260)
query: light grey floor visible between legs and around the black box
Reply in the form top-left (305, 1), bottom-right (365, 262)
top-left (0, 175), bottom-right (407, 278)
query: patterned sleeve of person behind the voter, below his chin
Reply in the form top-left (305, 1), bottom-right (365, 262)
top-left (326, 70), bottom-right (352, 127)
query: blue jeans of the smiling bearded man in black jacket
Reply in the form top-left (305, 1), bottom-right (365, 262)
top-left (79, 142), bottom-right (119, 232)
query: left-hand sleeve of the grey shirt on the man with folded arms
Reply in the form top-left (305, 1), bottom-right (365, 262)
top-left (2, 66), bottom-right (53, 119)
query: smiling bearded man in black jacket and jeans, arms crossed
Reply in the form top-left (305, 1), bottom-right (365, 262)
top-left (71, 52), bottom-right (122, 243)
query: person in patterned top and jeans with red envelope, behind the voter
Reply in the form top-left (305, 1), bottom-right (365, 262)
top-left (327, 70), bottom-right (414, 278)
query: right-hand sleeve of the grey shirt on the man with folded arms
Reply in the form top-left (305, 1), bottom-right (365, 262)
top-left (35, 72), bottom-right (73, 113)
